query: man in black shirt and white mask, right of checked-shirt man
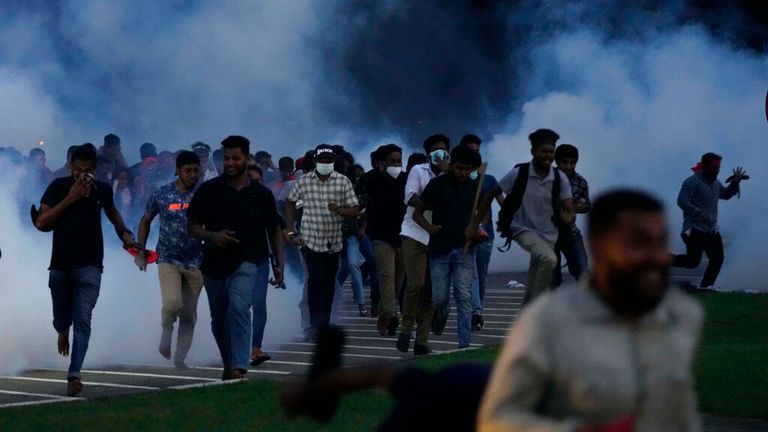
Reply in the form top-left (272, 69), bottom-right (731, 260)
top-left (366, 144), bottom-right (410, 340)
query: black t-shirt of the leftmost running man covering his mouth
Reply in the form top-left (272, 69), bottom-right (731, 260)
top-left (40, 176), bottom-right (115, 271)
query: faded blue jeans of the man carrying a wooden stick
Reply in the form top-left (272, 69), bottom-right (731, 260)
top-left (429, 247), bottom-right (475, 348)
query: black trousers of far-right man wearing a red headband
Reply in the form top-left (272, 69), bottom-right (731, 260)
top-left (672, 229), bottom-right (724, 287)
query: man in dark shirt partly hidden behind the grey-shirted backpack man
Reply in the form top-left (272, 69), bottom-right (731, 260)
top-left (551, 144), bottom-right (592, 288)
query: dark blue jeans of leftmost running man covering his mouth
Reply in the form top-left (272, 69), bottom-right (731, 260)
top-left (48, 266), bottom-right (101, 378)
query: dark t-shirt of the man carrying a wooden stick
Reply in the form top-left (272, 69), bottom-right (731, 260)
top-left (421, 174), bottom-right (477, 254)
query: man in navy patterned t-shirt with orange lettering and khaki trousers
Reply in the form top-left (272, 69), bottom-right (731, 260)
top-left (136, 151), bottom-right (203, 369)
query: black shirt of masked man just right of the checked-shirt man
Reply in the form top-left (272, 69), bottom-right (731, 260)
top-left (366, 171), bottom-right (408, 247)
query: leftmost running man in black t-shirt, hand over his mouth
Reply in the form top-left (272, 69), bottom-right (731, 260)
top-left (35, 145), bottom-right (134, 396)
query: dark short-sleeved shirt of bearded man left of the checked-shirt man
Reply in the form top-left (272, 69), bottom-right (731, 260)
top-left (187, 176), bottom-right (279, 276)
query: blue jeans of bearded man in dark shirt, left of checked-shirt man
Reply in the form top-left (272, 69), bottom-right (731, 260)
top-left (203, 262), bottom-right (259, 370)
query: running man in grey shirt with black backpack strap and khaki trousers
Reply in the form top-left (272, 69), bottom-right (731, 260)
top-left (467, 129), bottom-right (575, 305)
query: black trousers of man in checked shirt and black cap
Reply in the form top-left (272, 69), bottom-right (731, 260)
top-left (301, 247), bottom-right (339, 330)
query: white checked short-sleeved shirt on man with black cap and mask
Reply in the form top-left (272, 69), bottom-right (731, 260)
top-left (288, 171), bottom-right (359, 252)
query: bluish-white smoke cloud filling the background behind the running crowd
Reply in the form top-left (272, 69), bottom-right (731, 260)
top-left (0, 0), bottom-right (768, 371)
